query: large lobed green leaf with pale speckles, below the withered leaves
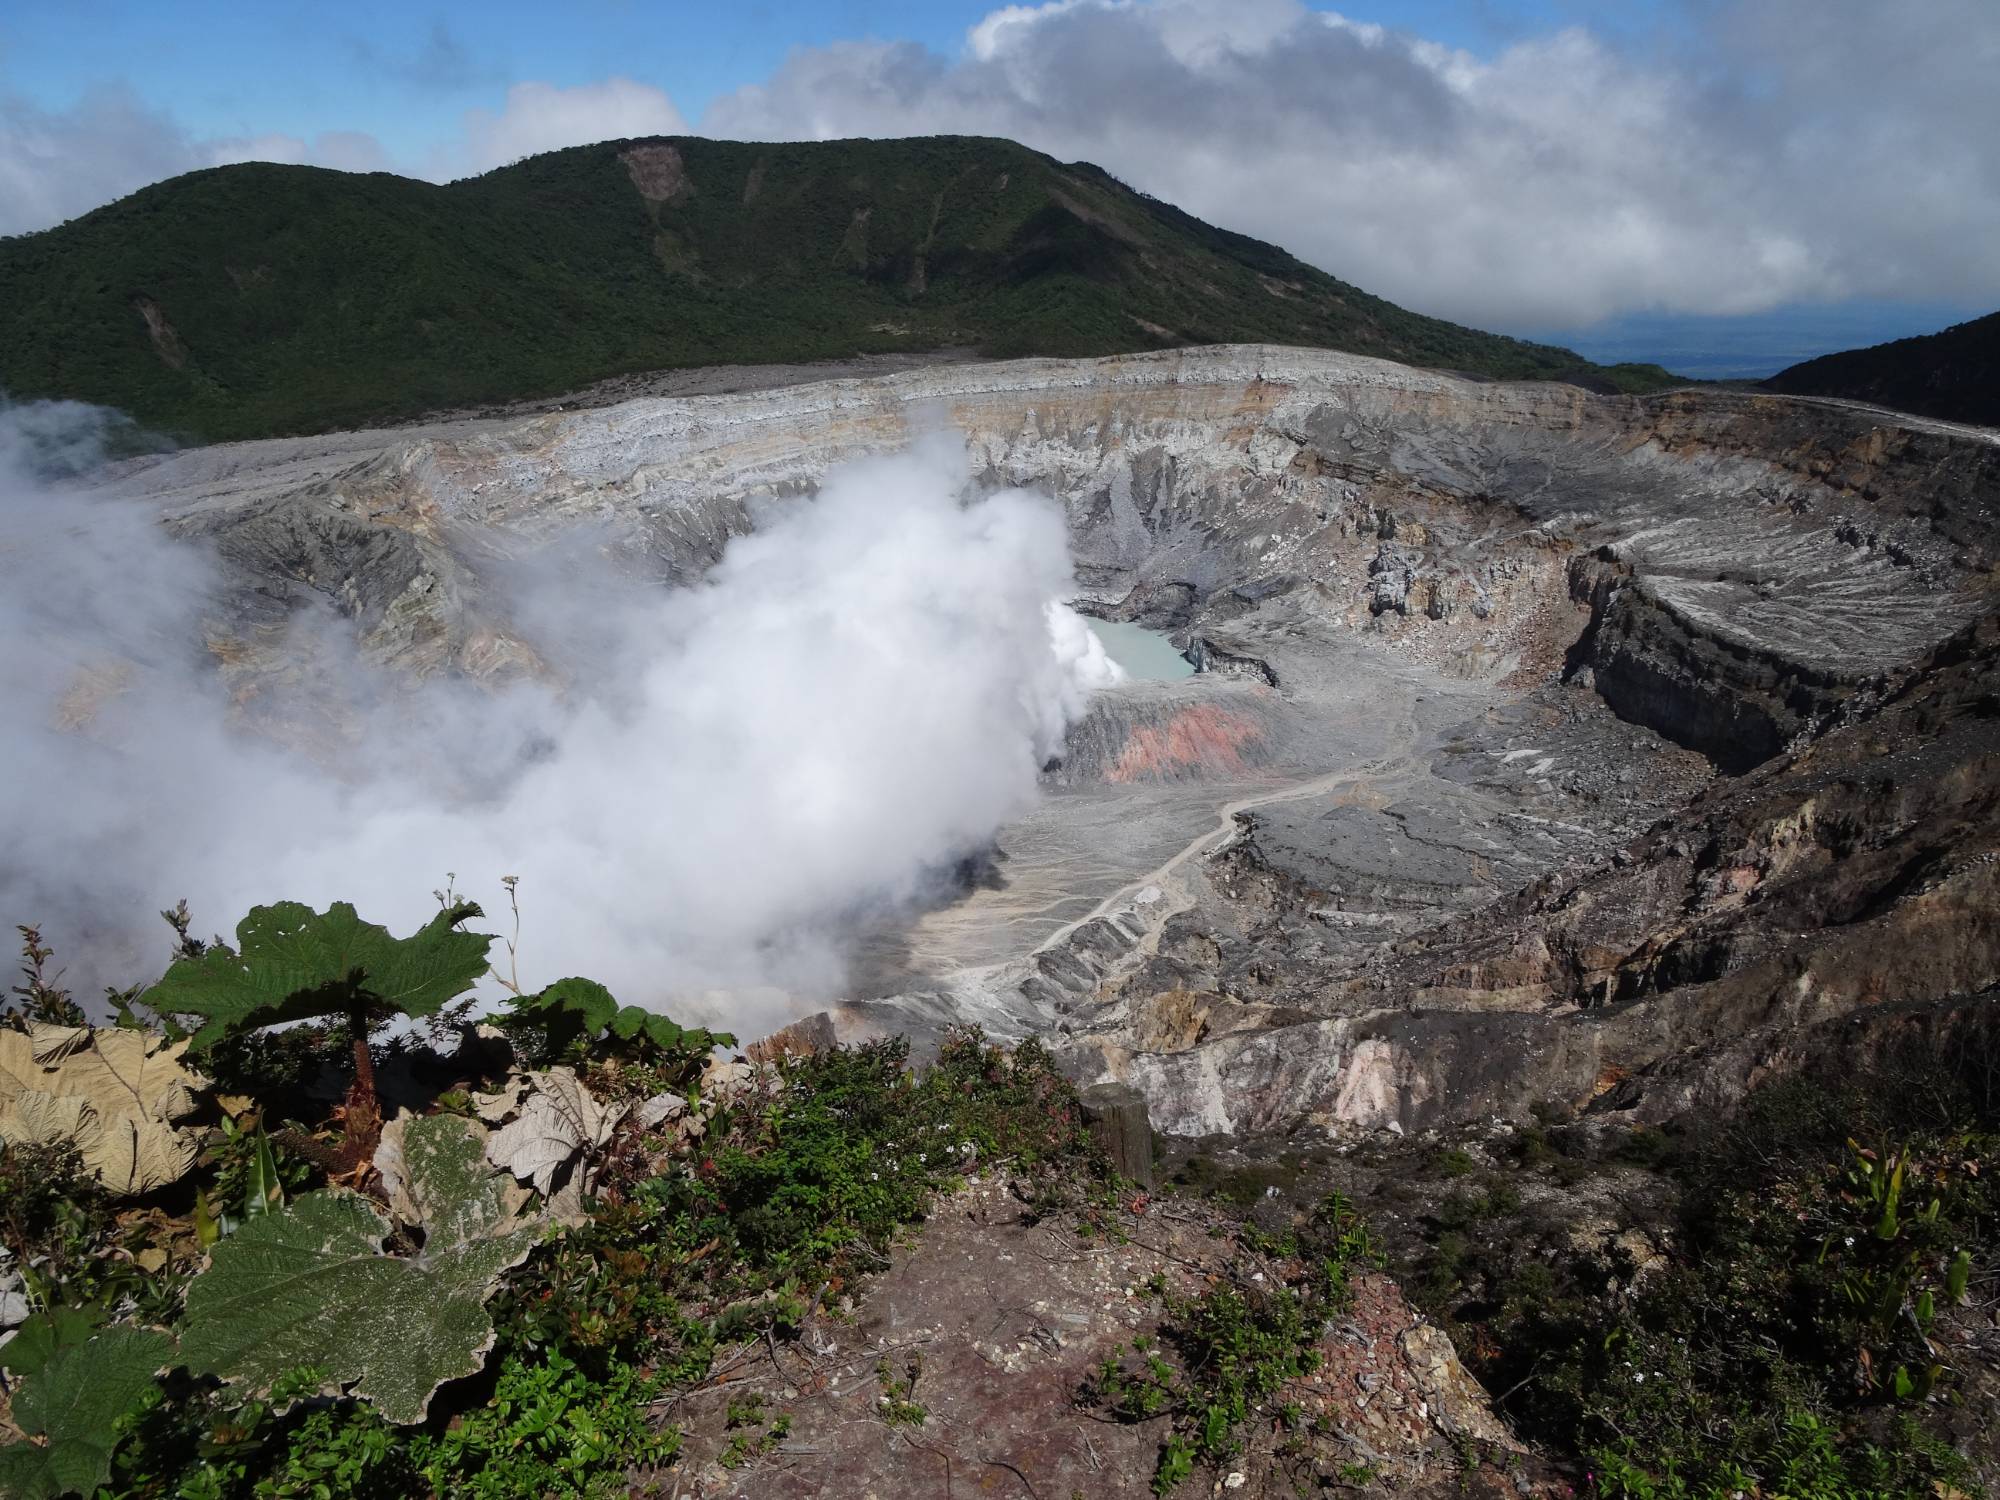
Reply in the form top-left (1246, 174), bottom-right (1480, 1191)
top-left (182, 1114), bottom-right (542, 1422)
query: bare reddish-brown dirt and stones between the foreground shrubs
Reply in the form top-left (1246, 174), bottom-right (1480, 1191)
top-left (666, 1176), bottom-right (1568, 1500)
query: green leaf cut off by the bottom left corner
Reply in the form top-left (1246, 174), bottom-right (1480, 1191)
top-left (0, 1328), bottom-right (174, 1500)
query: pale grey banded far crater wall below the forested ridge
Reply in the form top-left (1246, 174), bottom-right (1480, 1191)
top-left (122, 346), bottom-right (2000, 768)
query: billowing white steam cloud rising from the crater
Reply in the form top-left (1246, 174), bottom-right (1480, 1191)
top-left (0, 404), bottom-right (1118, 1026)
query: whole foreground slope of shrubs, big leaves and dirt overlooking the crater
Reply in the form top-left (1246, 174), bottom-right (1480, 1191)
top-left (0, 898), bottom-right (2000, 1498)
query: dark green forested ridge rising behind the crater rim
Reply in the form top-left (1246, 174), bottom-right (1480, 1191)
top-left (0, 136), bottom-right (1668, 438)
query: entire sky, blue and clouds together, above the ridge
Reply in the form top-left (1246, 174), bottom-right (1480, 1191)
top-left (0, 0), bottom-right (2000, 374)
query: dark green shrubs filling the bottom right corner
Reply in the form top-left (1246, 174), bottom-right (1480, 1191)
top-left (1464, 1120), bottom-right (2000, 1500)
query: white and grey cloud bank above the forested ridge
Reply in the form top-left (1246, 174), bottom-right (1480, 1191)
top-left (0, 0), bottom-right (2000, 328)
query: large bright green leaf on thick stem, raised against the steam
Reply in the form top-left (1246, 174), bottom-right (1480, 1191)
top-left (140, 902), bottom-right (492, 1052)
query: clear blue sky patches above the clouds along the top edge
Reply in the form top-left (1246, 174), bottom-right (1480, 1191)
top-left (0, 0), bottom-right (1672, 154)
